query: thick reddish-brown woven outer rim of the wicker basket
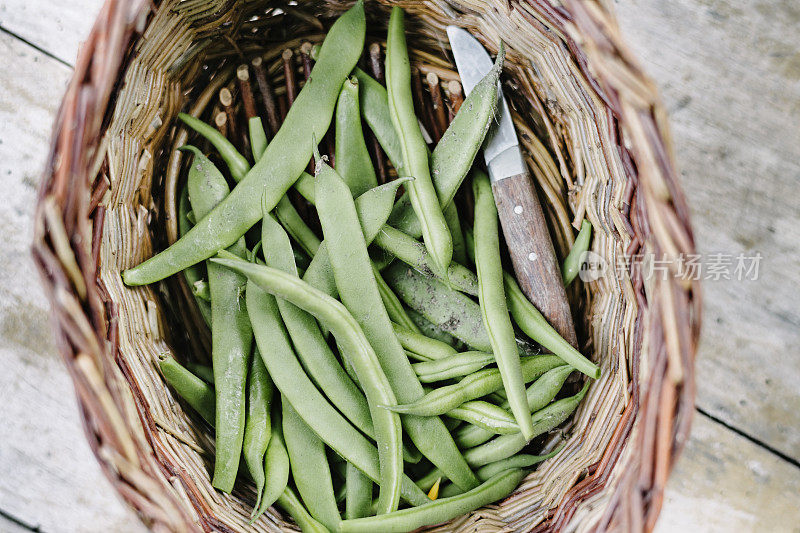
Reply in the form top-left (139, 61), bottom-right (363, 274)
top-left (32, 0), bottom-right (701, 531)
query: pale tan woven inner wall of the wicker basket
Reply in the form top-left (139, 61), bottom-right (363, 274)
top-left (98, 0), bottom-right (648, 531)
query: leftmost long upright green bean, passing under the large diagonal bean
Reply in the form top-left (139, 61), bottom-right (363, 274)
top-left (184, 146), bottom-right (253, 492)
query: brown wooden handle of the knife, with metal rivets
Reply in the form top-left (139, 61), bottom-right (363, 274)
top-left (492, 169), bottom-right (577, 347)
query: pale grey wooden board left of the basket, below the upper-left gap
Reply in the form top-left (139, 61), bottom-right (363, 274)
top-left (0, 29), bottom-right (142, 533)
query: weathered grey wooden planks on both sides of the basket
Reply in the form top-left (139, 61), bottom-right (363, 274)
top-left (0, 0), bottom-right (800, 533)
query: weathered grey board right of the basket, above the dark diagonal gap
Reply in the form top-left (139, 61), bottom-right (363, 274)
top-left (618, 0), bottom-right (800, 460)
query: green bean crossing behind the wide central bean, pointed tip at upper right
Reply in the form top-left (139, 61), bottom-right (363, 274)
top-left (303, 179), bottom-right (407, 298)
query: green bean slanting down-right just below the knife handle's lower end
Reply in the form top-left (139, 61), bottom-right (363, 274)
top-left (504, 273), bottom-right (600, 379)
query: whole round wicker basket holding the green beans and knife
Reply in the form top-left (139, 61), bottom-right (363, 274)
top-left (33, 0), bottom-right (700, 532)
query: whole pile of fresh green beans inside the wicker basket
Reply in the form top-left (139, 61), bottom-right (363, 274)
top-left (139, 1), bottom-right (600, 533)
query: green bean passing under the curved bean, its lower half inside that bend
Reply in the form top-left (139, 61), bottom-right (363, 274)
top-left (261, 214), bottom-right (375, 439)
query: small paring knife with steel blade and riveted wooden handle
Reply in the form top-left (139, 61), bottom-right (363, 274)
top-left (447, 26), bottom-right (577, 346)
